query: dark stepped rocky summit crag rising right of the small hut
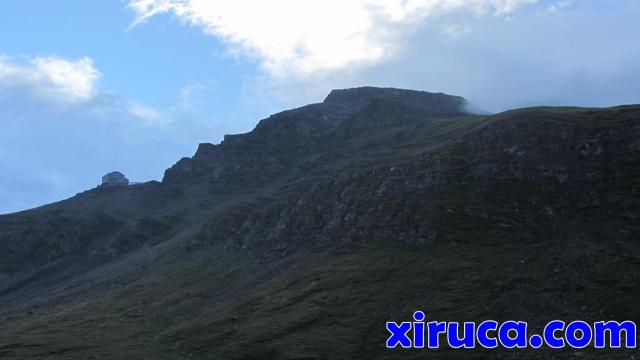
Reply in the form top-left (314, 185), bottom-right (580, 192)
top-left (163, 87), bottom-right (466, 186)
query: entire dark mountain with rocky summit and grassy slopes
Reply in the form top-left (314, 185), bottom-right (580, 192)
top-left (0, 87), bottom-right (640, 359)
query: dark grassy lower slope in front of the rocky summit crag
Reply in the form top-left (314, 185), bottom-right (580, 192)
top-left (0, 104), bottom-right (640, 359)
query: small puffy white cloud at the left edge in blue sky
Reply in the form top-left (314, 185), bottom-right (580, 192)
top-left (0, 56), bottom-right (101, 104)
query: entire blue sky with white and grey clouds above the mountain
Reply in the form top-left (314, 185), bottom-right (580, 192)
top-left (0, 0), bottom-right (640, 214)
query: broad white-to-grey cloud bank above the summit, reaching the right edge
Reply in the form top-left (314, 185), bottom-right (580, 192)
top-left (128, 0), bottom-right (640, 112)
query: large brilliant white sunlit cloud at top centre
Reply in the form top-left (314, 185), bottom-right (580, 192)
top-left (129, 0), bottom-right (538, 77)
